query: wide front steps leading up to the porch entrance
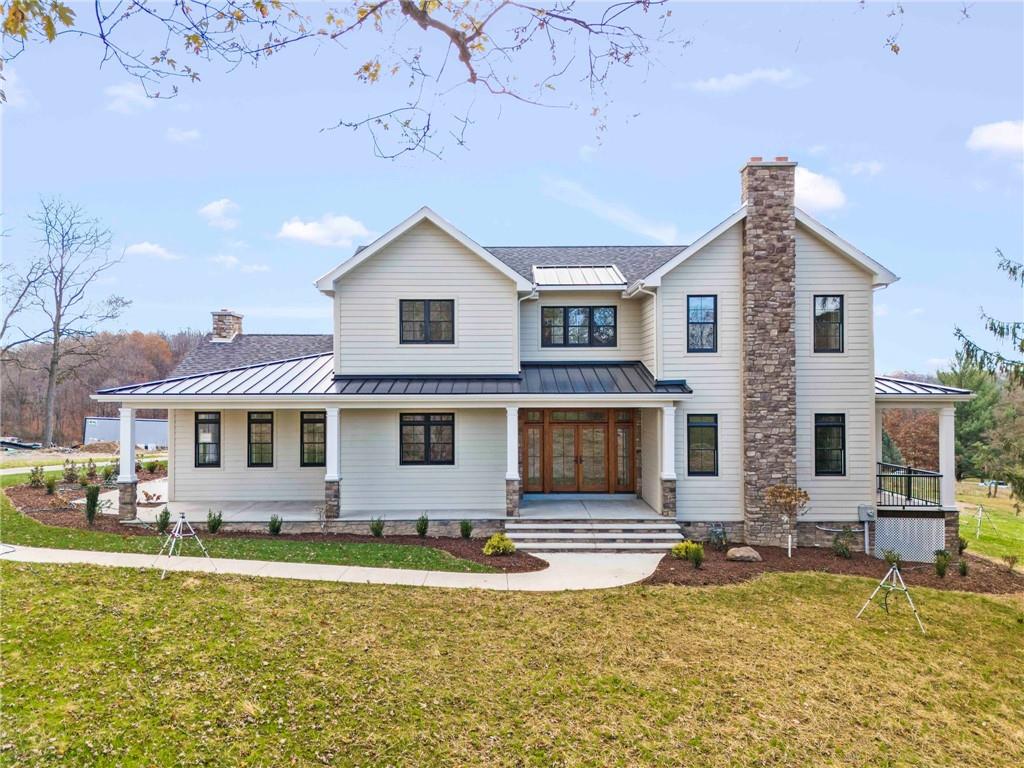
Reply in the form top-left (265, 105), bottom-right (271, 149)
top-left (505, 517), bottom-right (683, 552)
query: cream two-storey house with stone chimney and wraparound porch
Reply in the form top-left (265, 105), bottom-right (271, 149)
top-left (96, 158), bottom-right (971, 555)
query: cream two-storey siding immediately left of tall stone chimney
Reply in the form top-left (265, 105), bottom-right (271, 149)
top-left (657, 224), bottom-right (743, 520)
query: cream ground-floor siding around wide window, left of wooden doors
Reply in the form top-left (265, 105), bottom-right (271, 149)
top-left (341, 409), bottom-right (505, 513)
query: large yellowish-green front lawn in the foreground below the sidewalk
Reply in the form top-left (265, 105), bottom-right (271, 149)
top-left (0, 563), bottom-right (1024, 768)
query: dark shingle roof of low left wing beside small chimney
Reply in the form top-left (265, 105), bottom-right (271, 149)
top-left (171, 334), bottom-right (334, 377)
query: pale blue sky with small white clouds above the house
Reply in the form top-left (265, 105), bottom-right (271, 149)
top-left (2, 2), bottom-right (1024, 372)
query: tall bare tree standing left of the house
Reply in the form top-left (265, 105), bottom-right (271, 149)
top-left (29, 198), bottom-right (131, 444)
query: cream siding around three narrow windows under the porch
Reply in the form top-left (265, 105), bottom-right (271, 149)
top-left (169, 409), bottom-right (325, 501)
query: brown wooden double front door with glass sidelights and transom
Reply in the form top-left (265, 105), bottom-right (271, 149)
top-left (521, 410), bottom-right (635, 494)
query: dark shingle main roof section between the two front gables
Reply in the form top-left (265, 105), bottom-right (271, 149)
top-left (486, 246), bottom-right (686, 283)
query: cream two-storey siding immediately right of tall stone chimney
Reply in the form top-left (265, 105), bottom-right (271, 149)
top-left (797, 228), bottom-right (874, 520)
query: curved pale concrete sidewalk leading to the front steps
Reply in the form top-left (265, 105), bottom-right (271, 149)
top-left (0, 544), bottom-right (662, 592)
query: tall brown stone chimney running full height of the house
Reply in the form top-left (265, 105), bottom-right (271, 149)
top-left (739, 157), bottom-right (797, 546)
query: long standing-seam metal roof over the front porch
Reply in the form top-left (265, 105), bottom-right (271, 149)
top-left (99, 354), bottom-right (692, 397)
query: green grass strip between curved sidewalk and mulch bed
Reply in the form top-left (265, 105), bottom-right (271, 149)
top-left (0, 495), bottom-right (495, 573)
